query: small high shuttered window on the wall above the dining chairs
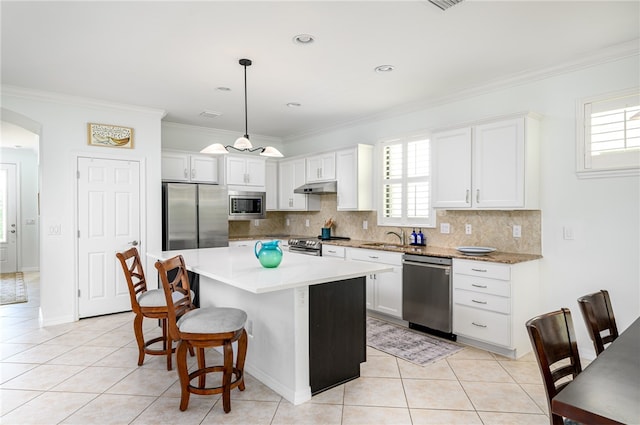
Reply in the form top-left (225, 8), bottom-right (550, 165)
top-left (578, 89), bottom-right (640, 177)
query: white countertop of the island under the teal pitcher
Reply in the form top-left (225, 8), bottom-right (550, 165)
top-left (147, 246), bottom-right (393, 294)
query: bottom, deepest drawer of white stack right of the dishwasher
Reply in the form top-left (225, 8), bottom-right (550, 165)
top-left (453, 304), bottom-right (511, 347)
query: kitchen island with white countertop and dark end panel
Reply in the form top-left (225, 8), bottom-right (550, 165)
top-left (147, 246), bottom-right (391, 404)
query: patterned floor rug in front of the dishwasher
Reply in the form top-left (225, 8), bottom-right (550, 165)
top-left (367, 317), bottom-right (463, 366)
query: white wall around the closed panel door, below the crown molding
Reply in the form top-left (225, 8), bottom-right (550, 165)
top-left (2, 87), bottom-right (164, 325)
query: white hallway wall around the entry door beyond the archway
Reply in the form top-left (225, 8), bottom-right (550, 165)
top-left (0, 147), bottom-right (40, 271)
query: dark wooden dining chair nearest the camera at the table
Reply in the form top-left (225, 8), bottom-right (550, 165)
top-left (526, 308), bottom-right (582, 425)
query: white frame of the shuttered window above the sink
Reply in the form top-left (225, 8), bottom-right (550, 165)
top-left (375, 132), bottom-right (436, 228)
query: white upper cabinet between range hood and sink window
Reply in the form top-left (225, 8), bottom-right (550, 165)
top-left (336, 145), bottom-right (373, 211)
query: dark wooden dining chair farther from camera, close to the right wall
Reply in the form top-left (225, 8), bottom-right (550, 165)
top-left (578, 289), bottom-right (618, 356)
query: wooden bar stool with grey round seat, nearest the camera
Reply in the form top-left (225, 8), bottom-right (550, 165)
top-left (155, 255), bottom-right (247, 413)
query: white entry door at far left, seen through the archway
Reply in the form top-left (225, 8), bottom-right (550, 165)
top-left (0, 164), bottom-right (18, 273)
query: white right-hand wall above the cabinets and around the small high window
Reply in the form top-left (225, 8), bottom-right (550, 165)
top-left (285, 55), bottom-right (640, 357)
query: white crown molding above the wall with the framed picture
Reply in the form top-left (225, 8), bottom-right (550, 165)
top-left (2, 84), bottom-right (167, 119)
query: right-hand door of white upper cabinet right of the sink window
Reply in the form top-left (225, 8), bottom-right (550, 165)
top-left (473, 118), bottom-right (525, 208)
